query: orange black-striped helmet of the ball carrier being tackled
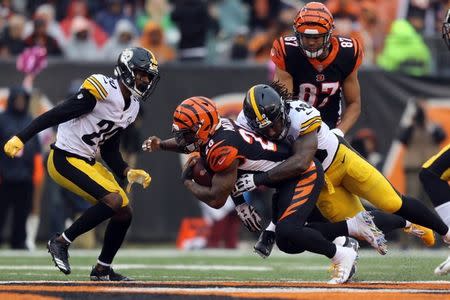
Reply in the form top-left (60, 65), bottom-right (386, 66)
top-left (172, 96), bottom-right (220, 153)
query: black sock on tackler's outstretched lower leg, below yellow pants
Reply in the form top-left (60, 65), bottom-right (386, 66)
top-left (395, 196), bottom-right (448, 235)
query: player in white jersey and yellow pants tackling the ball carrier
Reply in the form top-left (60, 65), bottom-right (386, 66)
top-left (234, 85), bottom-right (450, 257)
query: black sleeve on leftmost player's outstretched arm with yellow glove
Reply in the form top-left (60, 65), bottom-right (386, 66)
top-left (17, 89), bottom-right (97, 143)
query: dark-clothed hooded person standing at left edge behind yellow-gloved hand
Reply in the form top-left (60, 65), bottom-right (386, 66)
top-left (0, 87), bottom-right (44, 249)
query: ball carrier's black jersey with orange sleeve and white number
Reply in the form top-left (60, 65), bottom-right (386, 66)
top-left (200, 118), bottom-right (291, 172)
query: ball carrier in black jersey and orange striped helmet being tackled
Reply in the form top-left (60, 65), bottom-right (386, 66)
top-left (143, 97), bottom-right (385, 284)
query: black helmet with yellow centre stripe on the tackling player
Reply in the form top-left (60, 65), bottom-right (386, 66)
top-left (243, 84), bottom-right (289, 140)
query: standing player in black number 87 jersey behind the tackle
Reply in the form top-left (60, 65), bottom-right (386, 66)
top-left (271, 2), bottom-right (363, 136)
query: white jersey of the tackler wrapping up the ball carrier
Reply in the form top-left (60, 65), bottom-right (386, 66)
top-left (236, 100), bottom-right (339, 170)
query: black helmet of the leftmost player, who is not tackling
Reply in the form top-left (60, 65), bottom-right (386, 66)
top-left (114, 47), bottom-right (159, 101)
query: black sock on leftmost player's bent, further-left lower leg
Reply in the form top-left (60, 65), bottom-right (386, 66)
top-left (64, 202), bottom-right (114, 241)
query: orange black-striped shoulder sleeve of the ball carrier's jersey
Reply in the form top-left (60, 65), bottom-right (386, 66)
top-left (206, 140), bottom-right (239, 172)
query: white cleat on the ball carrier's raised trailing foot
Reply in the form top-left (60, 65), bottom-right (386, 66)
top-left (347, 211), bottom-right (387, 255)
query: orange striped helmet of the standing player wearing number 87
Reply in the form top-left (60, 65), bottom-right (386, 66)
top-left (294, 2), bottom-right (334, 58)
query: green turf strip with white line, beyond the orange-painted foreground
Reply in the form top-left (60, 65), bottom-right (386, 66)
top-left (0, 247), bottom-right (450, 281)
